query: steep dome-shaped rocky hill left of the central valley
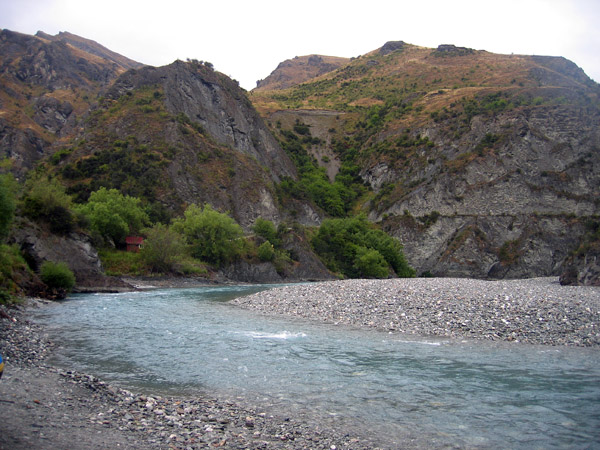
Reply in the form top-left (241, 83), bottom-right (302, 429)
top-left (57, 61), bottom-right (308, 228)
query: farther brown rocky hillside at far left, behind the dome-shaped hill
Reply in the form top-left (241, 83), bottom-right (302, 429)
top-left (0, 30), bottom-right (132, 178)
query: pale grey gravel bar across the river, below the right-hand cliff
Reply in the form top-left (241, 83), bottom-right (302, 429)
top-left (232, 278), bottom-right (600, 347)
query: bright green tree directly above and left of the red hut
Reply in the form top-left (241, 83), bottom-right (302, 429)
top-left (76, 188), bottom-right (149, 243)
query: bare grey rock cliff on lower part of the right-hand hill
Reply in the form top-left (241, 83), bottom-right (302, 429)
top-left (363, 107), bottom-right (600, 278)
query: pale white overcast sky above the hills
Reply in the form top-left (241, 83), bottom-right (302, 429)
top-left (0, 0), bottom-right (600, 90)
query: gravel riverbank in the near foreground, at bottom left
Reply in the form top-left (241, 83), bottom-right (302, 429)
top-left (0, 301), bottom-right (398, 450)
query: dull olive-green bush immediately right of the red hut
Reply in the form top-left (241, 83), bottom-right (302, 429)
top-left (140, 224), bottom-right (185, 273)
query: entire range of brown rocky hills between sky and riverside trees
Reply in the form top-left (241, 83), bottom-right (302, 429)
top-left (0, 30), bottom-right (600, 284)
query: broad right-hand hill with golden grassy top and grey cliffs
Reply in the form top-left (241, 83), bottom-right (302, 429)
top-left (251, 41), bottom-right (600, 278)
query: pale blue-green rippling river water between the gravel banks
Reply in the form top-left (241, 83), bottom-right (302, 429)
top-left (32, 286), bottom-right (600, 448)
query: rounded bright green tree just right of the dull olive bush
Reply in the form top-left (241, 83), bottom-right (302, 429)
top-left (173, 204), bottom-right (245, 266)
